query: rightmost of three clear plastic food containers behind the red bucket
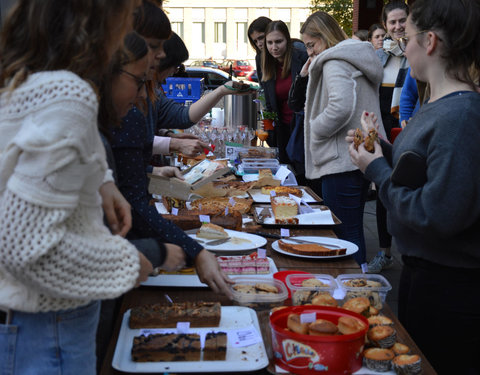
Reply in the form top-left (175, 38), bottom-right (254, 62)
top-left (337, 273), bottom-right (392, 310)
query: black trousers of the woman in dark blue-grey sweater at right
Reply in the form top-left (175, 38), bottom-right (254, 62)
top-left (398, 258), bottom-right (480, 375)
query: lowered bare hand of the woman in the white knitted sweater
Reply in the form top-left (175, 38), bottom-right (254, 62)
top-left (99, 181), bottom-right (132, 237)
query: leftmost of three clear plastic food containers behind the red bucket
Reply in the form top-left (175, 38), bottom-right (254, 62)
top-left (231, 277), bottom-right (288, 310)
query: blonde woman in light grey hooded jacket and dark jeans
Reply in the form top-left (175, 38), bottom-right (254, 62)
top-left (300, 11), bottom-right (385, 264)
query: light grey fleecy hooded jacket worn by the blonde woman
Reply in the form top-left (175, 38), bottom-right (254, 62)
top-left (305, 39), bottom-right (385, 179)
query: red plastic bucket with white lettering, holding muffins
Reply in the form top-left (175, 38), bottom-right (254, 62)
top-left (270, 305), bottom-right (368, 375)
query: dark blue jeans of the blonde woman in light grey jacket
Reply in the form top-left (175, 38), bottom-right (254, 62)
top-left (312, 170), bottom-right (369, 264)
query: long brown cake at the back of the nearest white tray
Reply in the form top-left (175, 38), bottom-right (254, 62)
top-left (129, 302), bottom-right (221, 329)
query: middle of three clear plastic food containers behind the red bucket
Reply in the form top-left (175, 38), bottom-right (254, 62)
top-left (286, 273), bottom-right (337, 306)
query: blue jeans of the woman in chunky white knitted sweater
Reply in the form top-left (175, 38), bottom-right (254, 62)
top-left (0, 301), bottom-right (100, 375)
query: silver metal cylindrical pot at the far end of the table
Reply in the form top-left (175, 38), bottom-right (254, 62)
top-left (224, 92), bottom-right (258, 129)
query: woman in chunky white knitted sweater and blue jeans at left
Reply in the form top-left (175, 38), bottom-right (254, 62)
top-left (0, 0), bottom-right (152, 375)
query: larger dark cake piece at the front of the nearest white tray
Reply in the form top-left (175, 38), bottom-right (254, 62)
top-left (132, 333), bottom-right (201, 362)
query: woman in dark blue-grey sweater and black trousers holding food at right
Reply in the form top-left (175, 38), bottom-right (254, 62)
top-left (348, 0), bottom-right (480, 374)
